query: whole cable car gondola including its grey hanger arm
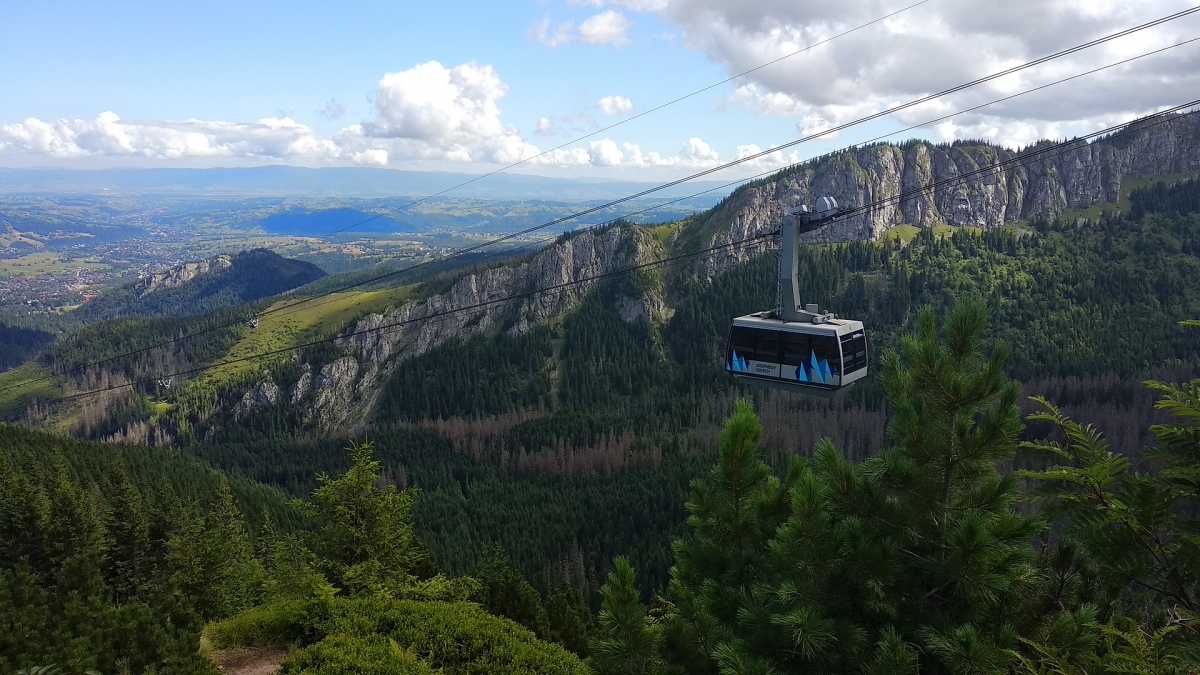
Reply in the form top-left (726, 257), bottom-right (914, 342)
top-left (725, 197), bottom-right (866, 396)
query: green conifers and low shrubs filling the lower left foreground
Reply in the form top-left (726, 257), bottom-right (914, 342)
top-left (0, 426), bottom-right (587, 675)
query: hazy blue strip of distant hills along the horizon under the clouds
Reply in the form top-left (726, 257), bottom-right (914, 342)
top-left (0, 166), bottom-right (730, 200)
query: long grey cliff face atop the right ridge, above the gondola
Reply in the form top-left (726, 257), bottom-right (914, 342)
top-left (701, 114), bottom-right (1200, 276)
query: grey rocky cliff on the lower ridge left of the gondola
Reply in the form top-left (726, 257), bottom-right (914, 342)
top-left (302, 226), bottom-right (667, 429)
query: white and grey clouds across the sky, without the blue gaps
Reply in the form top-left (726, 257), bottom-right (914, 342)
top-left (0, 0), bottom-right (1200, 171)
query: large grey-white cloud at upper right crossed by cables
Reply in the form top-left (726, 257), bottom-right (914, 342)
top-left (580, 0), bottom-right (1200, 143)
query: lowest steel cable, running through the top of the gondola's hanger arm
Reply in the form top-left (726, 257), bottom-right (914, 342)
top-left (35, 100), bottom-right (1200, 402)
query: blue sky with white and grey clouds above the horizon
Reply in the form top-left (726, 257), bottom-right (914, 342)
top-left (0, 0), bottom-right (1200, 180)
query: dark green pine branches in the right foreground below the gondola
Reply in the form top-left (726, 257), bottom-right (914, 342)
top-left (589, 301), bottom-right (1200, 675)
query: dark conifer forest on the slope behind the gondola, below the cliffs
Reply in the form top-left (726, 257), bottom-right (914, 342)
top-left (175, 181), bottom-right (1200, 589)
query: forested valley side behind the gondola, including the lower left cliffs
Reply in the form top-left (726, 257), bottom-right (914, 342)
top-left (0, 152), bottom-right (1200, 610)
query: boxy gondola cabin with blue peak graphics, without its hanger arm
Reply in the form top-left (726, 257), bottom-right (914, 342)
top-left (725, 312), bottom-right (866, 395)
